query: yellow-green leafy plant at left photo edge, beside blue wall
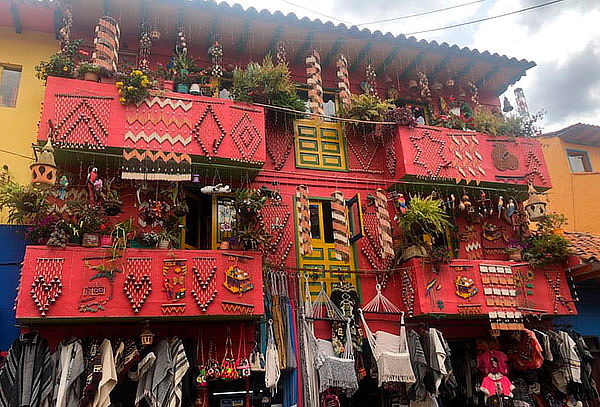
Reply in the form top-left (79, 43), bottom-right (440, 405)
top-left (0, 181), bottom-right (48, 224)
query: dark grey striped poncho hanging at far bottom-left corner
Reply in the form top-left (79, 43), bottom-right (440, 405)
top-left (0, 331), bottom-right (52, 407)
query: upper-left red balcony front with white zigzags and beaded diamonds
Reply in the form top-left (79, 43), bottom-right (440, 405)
top-left (38, 77), bottom-right (266, 175)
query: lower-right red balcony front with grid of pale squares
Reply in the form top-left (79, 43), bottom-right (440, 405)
top-left (403, 259), bottom-right (577, 318)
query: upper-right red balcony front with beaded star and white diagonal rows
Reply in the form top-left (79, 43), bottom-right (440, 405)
top-left (390, 126), bottom-right (551, 189)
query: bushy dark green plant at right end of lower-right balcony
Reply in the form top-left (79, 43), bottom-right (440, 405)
top-left (523, 233), bottom-right (572, 267)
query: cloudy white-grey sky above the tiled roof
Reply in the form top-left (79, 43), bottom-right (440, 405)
top-left (221, 0), bottom-right (600, 131)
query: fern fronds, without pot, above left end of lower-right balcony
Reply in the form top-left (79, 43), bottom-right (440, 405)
top-left (399, 196), bottom-right (450, 244)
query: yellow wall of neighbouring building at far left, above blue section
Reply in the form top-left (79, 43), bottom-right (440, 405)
top-left (0, 27), bottom-right (58, 188)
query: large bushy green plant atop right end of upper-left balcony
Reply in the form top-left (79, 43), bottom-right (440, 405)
top-left (231, 55), bottom-right (305, 111)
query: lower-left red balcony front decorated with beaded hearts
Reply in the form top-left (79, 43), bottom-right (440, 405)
top-left (16, 246), bottom-right (264, 322)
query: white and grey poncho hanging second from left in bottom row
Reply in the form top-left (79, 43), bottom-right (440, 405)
top-left (52, 337), bottom-right (85, 407)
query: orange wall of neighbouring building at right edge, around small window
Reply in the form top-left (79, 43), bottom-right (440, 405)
top-left (541, 137), bottom-right (600, 234)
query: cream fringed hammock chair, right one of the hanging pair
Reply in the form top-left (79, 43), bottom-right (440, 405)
top-left (359, 310), bottom-right (416, 386)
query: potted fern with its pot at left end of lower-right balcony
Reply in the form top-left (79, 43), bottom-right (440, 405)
top-left (399, 196), bottom-right (450, 260)
